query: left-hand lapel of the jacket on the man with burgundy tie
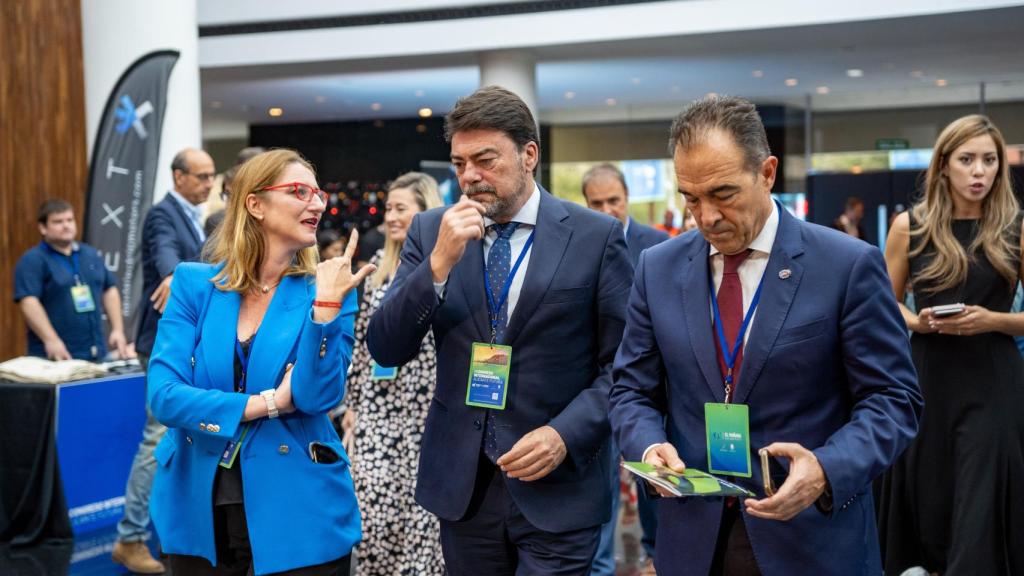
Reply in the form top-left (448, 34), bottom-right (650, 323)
top-left (676, 238), bottom-right (725, 402)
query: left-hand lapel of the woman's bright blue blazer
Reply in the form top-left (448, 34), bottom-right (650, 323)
top-left (201, 280), bottom-right (242, 392)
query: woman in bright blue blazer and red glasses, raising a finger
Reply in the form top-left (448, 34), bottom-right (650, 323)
top-left (147, 150), bottom-right (373, 576)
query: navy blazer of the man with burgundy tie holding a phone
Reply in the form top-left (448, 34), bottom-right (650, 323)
top-left (610, 206), bottom-right (923, 575)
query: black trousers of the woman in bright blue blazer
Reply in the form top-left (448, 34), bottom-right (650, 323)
top-left (168, 504), bottom-right (352, 576)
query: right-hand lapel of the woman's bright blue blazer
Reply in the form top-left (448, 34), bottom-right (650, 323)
top-left (246, 276), bottom-right (311, 394)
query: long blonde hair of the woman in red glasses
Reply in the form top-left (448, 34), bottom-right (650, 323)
top-left (203, 149), bottom-right (319, 294)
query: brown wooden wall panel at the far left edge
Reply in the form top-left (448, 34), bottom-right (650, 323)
top-left (0, 0), bottom-right (88, 360)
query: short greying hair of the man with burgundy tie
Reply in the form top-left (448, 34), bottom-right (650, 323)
top-left (669, 95), bottom-right (771, 170)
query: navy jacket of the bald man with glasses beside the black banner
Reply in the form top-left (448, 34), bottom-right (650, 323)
top-left (135, 194), bottom-right (203, 354)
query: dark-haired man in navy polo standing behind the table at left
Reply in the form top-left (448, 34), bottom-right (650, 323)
top-left (14, 200), bottom-right (128, 361)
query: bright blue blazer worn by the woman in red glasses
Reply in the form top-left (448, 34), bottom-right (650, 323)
top-left (146, 263), bottom-right (360, 574)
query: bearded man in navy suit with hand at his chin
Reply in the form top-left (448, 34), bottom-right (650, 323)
top-left (368, 86), bottom-right (633, 575)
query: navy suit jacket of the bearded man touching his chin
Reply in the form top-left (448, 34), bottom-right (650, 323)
top-left (367, 190), bottom-right (633, 532)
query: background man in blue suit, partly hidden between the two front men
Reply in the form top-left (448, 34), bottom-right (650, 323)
top-left (583, 164), bottom-right (669, 576)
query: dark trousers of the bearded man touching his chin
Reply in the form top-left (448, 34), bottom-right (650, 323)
top-left (441, 454), bottom-right (601, 576)
